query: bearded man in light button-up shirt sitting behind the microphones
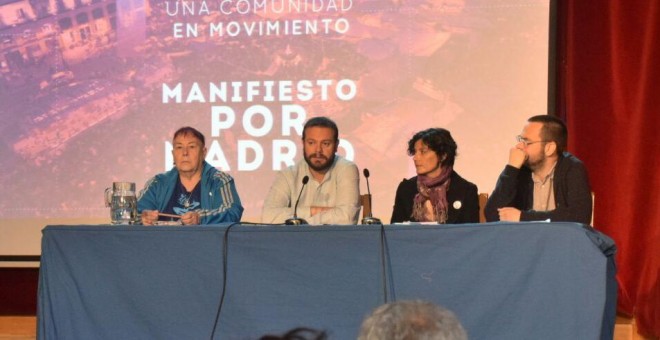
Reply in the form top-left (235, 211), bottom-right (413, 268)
top-left (261, 117), bottom-right (360, 224)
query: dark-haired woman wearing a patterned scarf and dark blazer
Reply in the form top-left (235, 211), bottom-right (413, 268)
top-left (391, 128), bottom-right (479, 224)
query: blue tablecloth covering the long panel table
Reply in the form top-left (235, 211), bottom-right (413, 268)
top-left (38, 223), bottom-right (616, 339)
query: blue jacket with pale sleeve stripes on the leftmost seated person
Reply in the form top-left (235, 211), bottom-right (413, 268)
top-left (138, 161), bottom-right (243, 224)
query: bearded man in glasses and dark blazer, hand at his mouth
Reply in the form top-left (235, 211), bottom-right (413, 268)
top-left (485, 115), bottom-right (592, 224)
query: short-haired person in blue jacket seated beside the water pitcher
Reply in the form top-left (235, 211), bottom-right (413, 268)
top-left (138, 126), bottom-right (243, 225)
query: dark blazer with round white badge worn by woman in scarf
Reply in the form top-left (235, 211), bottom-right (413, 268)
top-left (391, 171), bottom-right (479, 224)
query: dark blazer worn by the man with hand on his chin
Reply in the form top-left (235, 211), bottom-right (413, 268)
top-left (485, 152), bottom-right (593, 224)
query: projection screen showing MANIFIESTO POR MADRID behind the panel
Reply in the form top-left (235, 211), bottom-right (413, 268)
top-left (0, 0), bottom-right (550, 255)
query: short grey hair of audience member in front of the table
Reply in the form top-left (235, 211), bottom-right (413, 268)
top-left (358, 300), bottom-right (467, 340)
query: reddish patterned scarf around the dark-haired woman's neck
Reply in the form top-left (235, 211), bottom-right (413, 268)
top-left (412, 166), bottom-right (453, 223)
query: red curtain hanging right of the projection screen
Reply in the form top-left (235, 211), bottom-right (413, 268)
top-left (556, 0), bottom-right (660, 336)
